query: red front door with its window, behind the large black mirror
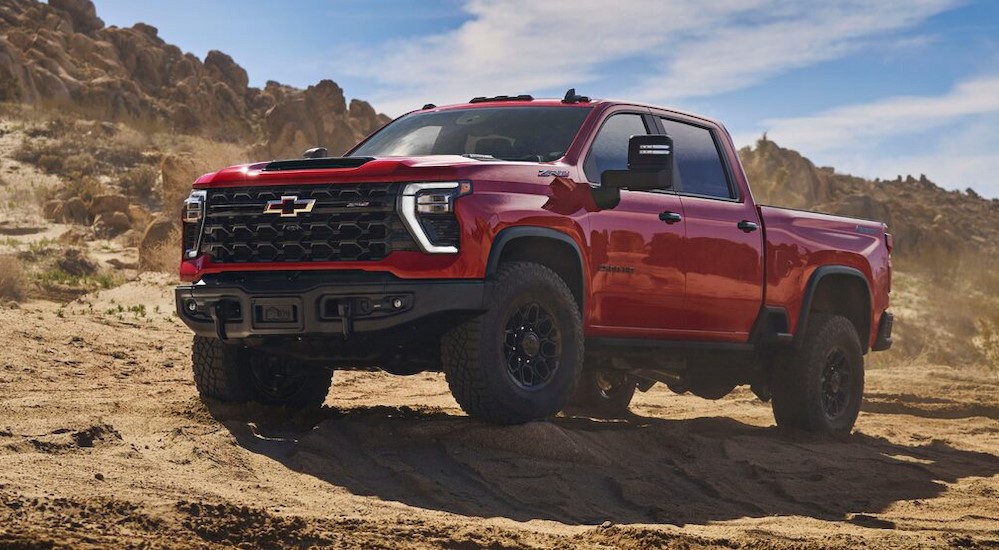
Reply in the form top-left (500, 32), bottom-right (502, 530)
top-left (583, 109), bottom-right (684, 338)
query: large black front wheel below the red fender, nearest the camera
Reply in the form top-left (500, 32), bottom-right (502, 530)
top-left (441, 262), bottom-right (583, 424)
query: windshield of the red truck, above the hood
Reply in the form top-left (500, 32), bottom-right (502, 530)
top-left (350, 107), bottom-right (590, 162)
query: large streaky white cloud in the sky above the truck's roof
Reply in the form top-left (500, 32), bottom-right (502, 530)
top-left (337, 0), bottom-right (956, 114)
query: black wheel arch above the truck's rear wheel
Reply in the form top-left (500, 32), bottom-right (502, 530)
top-left (794, 265), bottom-right (871, 354)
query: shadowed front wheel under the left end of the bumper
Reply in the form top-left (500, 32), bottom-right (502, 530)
top-left (191, 336), bottom-right (333, 408)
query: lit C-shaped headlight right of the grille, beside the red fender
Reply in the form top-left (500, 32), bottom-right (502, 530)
top-left (399, 181), bottom-right (472, 254)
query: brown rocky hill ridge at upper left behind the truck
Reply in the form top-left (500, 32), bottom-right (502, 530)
top-left (0, 0), bottom-right (388, 158)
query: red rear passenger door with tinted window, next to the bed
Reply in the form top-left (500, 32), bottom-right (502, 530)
top-left (657, 116), bottom-right (764, 341)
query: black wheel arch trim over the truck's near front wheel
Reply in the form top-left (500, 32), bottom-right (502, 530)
top-left (486, 226), bottom-right (586, 314)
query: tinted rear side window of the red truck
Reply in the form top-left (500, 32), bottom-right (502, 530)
top-left (662, 118), bottom-right (734, 199)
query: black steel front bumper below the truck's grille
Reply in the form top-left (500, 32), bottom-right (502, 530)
top-left (175, 278), bottom-right (484, 340)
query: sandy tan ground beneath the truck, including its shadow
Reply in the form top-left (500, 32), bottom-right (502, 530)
top-left (0, 275), bottom-right (999, 548)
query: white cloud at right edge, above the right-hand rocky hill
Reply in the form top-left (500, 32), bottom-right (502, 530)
top-left (760, 75), bottom-right (999, 198)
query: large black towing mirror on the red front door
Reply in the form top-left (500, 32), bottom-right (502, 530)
top-left (600, 135), bottom-right (673, 191)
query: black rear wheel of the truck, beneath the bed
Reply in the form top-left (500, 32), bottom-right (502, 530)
top-left (771, 313), bottom-right (864, 433)
